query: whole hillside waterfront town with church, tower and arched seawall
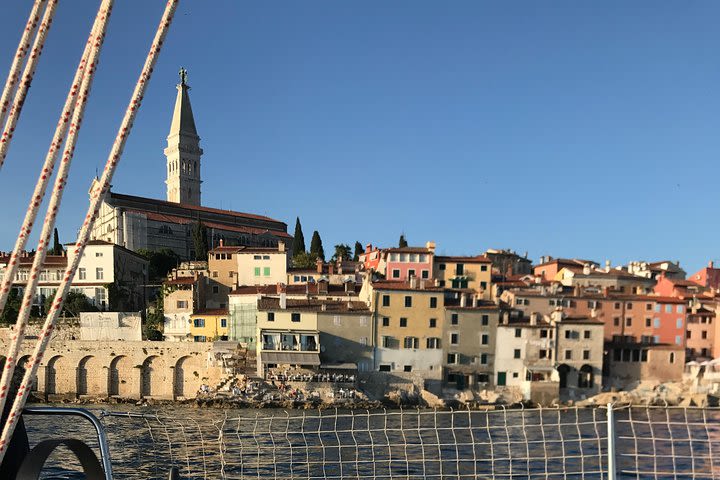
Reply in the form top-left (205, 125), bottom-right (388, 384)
top-left (0, 75), bottom-right (720, 404)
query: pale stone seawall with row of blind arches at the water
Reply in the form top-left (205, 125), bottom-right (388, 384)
top-left (0, 338), bottom-right (222, 400)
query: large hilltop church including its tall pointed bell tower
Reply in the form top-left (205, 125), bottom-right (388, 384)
top-left (91, 69), bottom-right (292, 259)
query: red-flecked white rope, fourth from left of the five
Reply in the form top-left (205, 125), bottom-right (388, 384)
top-left (0, 0), bottom-right (114, 428)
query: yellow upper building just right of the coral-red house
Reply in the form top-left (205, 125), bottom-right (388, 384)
top-left (433, 255), bottom-right (492, 300)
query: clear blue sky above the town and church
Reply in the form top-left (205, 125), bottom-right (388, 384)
top-left (0, 0), bottom-right (720, 273)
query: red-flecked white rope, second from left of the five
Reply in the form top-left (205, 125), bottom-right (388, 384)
top-left (0, 0), bottom-right (58, 169)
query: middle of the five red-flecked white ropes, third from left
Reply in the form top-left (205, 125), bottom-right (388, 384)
top-left (0, 7), bottom-right (98, 326)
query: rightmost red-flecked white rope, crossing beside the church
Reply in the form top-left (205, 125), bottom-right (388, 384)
top-left (0, 0), bottom-right (179, 461)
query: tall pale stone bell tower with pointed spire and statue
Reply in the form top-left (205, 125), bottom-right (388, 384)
top-left (165, 68), bottom-right (203, 206)
